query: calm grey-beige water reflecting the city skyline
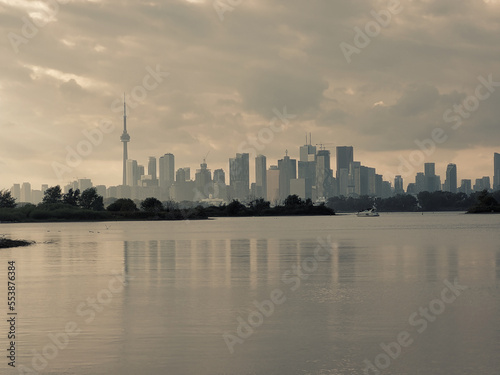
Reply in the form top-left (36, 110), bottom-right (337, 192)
top-left (0, 213), bottom-right (500, 375)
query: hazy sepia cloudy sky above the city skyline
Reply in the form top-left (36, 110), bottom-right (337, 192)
top-left (0, 0), bottom-right (500, 189)
